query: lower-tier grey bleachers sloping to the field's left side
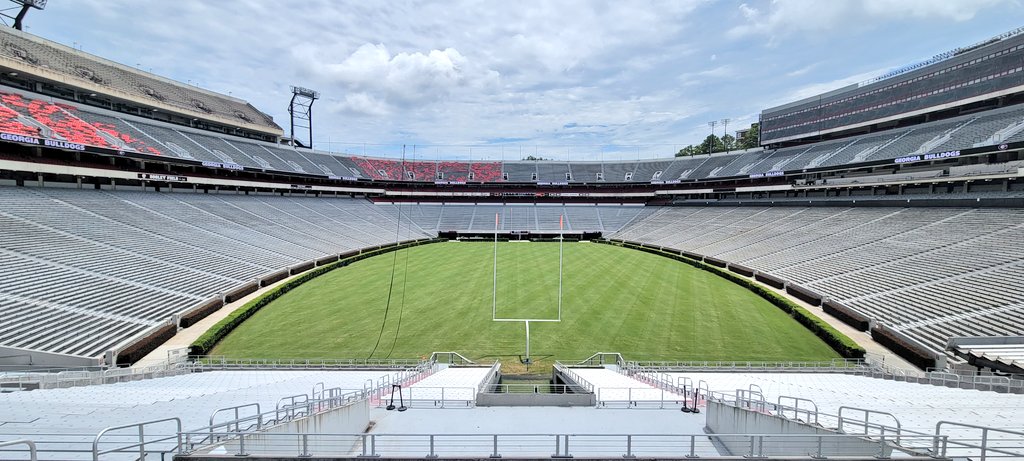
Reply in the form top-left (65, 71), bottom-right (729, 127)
top-left (0, 187), bottom-right (428, 357)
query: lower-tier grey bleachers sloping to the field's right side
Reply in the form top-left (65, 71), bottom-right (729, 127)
top-left (613, 207), bottom-right (1024, 358)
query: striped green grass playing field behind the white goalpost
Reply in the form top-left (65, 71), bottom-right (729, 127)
top-left (211, 242), bottom-right (839, 362)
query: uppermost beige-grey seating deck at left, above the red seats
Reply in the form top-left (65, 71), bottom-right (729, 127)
top-left (0, 30), bottom-right (280, 130)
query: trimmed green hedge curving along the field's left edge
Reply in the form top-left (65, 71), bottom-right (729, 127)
top-left (188, 239), bottom-right (442, 355)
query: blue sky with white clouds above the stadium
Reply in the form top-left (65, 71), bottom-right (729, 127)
top-left (18, 0), bottom-right (1024, 160)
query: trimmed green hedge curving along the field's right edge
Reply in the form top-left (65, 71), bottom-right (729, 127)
top-left (600, 240), bottom-right (865, 359)
